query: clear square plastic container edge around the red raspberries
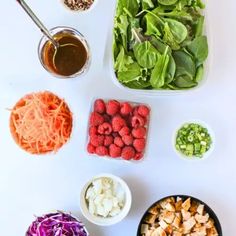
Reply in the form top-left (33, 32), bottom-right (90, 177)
top-left (85, 98), bottom-right (151, 163)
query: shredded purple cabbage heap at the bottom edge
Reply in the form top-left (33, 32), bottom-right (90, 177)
top-left (26, 212), bottom-right (89, 236)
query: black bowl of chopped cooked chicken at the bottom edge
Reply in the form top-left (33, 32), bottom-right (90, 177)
top-left (137, 195), bottom-right (223, 236)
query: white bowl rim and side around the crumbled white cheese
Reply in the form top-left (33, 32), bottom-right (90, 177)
top-left (80, 174), bottom-right (132, 226)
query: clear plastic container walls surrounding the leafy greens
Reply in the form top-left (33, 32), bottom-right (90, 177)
top-left (104, 0), bottom-right (211, 96)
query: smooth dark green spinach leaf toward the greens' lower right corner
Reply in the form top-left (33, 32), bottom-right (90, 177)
top-left (173, 51), bottom-right (196, 78)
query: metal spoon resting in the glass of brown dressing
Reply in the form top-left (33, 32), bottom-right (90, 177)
top-left (16, 0), bottom-right (76, 65)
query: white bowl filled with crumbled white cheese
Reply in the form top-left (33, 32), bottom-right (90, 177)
top-left (80, 174), bottom-right (132, 226)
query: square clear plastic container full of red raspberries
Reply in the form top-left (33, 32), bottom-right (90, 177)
top-left (86, 98), bottom-right (151, 163)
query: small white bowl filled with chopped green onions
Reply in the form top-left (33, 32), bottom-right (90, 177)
top-left (173, 120), bottom-right (214, 160)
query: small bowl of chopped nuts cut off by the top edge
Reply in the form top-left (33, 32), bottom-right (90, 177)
top-left (61, 0), bottom-right (98, 13)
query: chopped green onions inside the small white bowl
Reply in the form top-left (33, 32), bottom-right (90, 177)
top-left (175, 123), bottom-right (212, 158)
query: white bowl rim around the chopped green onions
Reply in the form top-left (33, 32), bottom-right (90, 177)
top-left (172, 119), bottom-right (215, 161)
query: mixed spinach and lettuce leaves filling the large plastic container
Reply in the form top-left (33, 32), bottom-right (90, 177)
top-left (112, 0), bottom-right (208, 94)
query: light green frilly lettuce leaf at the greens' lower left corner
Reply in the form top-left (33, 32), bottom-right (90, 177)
top-left (117, 62), bottom-right (142, 83)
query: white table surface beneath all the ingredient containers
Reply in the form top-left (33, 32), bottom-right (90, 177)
top-left (0, 0), bottom-right (236, 236)
